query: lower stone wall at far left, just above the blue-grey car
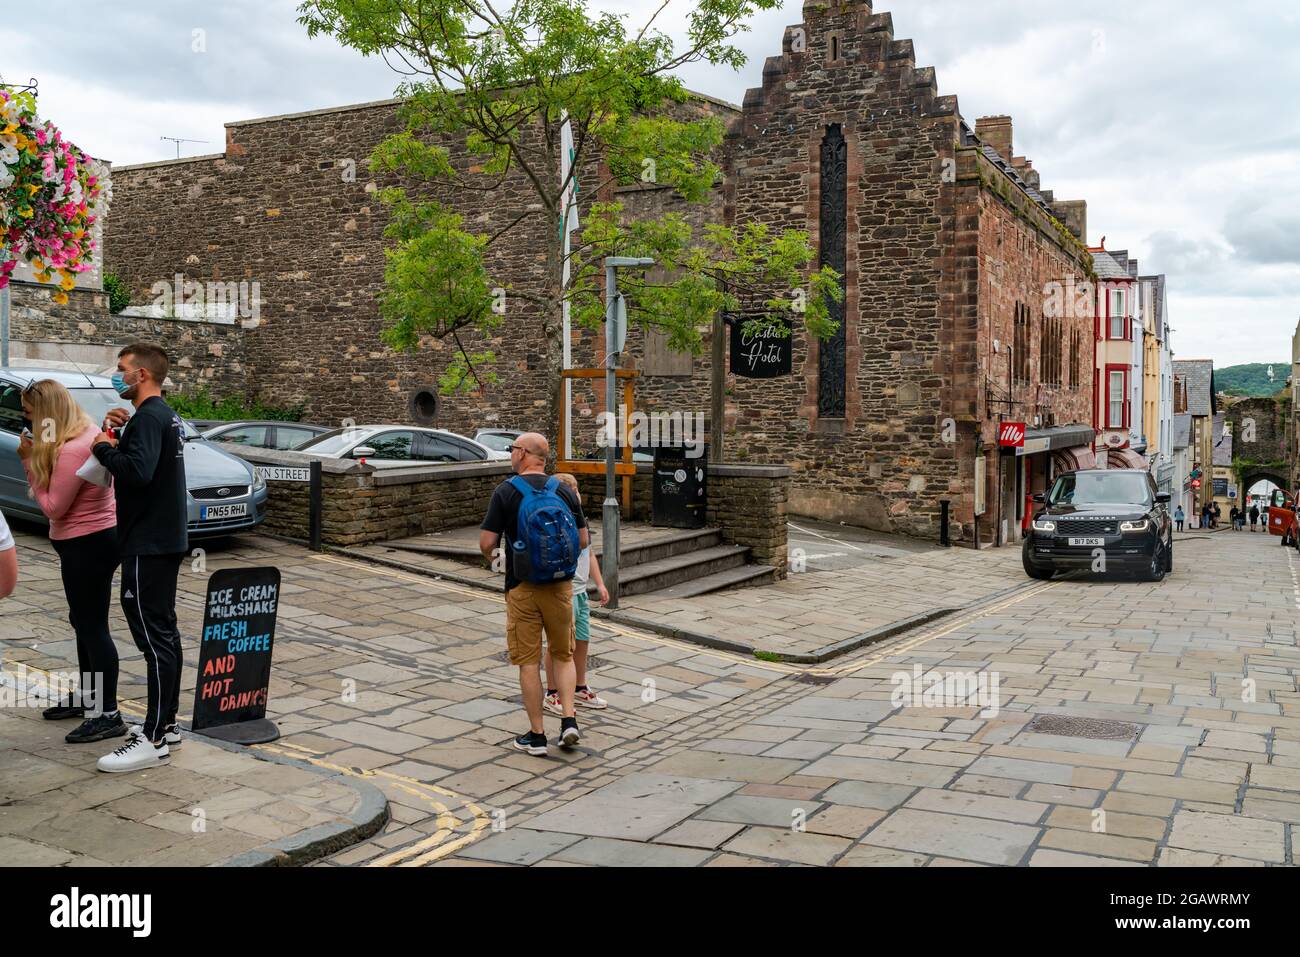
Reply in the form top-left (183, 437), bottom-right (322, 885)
top-left (9, 282), bottom-right (244, 389)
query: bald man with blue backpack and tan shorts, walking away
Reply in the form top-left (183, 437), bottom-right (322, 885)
top-left (478, 432), bottom-right (590, 757)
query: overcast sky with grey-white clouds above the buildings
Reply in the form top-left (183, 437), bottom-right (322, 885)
top-left (0, 0), bottom-right (1300, 372)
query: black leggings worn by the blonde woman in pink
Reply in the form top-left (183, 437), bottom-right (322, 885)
top-left (51, 528), bottom-right (121, 711)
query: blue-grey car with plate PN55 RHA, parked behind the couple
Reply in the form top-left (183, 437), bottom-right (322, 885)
top-left (0, 369), bottom-right (267, 537)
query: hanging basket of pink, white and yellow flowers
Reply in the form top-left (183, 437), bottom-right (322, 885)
top-left (0, 88), bottom-right (112, 304)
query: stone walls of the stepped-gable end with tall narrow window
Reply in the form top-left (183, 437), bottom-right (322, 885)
top-left (725, 0), bottom-right (1092, 542)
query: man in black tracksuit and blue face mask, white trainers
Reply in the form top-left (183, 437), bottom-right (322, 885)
top-left (92, 343), bottom-right (189, 771)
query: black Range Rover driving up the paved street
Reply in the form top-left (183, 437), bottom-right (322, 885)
top-left (1023, 468), bottom-right (1174, 581)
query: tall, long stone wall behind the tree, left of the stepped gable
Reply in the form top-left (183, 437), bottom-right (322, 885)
top-left (107, 98), bottom-right (729, 441)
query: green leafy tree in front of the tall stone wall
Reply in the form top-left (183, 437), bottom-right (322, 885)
top-left (299, 0), bottom-right (842, 436)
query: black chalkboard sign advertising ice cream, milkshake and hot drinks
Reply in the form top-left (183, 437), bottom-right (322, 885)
top-left (191, 568), bottom-right (280, 744)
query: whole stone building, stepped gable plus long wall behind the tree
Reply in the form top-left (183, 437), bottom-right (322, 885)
top-left (35, 1), bottom-right (1093, 544)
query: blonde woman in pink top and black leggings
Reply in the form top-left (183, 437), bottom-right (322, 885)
top-left (18, 378), bottom-right (126, 744)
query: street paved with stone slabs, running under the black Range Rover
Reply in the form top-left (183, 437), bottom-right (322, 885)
top-left (0, 522), bottom-right (1300, 866)
